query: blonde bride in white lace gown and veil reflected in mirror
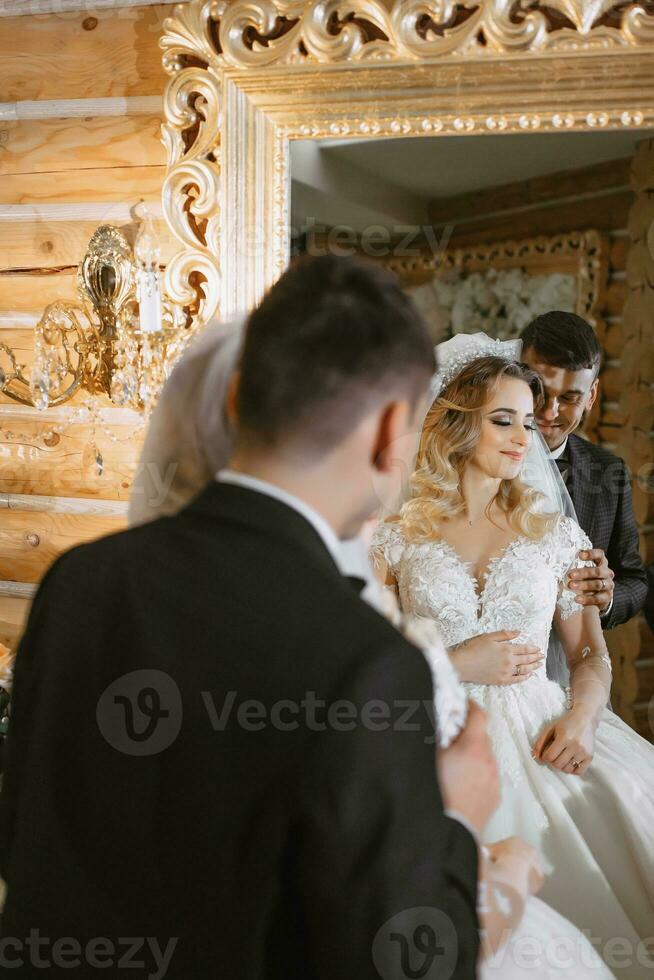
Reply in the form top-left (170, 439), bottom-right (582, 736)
top-left (373, 337), bottom-right (654, 980)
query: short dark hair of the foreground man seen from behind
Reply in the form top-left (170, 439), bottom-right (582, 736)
top-left (236, 255), bottom-right (434, 450)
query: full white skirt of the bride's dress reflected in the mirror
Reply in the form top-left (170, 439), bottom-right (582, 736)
top-left (465, 674), bottom-right (654, 980)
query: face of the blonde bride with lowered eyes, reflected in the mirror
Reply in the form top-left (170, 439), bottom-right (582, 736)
top-left (471, 378), bottom-right (536, 480)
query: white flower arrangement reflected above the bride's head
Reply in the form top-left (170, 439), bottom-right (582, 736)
top-left (411, 269), bottom-right (577, 341)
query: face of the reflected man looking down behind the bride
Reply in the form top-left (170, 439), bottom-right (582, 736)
top-left (522, 348), bottom-right (598, 451)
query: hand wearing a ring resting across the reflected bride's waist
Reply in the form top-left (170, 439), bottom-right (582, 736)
top-left (449, 630), bottom-right (545, 684)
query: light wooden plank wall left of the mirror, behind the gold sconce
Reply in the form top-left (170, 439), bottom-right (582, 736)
top-left (0, 4), bottom-right (176, 644)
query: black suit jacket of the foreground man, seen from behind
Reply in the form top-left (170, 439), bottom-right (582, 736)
top-left (0, 484), bottom-right (478, 980)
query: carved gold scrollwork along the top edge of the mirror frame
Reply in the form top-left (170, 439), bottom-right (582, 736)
top-left (208, 0), bottom-right (654, 68)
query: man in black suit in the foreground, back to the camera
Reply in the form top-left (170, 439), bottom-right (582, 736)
top-left (0, 257), bottom-right (498, 980)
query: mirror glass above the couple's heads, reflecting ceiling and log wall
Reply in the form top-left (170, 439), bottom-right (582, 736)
top-left (291, 132), bottom-right (651, 349)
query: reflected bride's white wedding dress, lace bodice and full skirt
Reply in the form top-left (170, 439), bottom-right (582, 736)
top-left (372, 518), bottom-right (654, 980)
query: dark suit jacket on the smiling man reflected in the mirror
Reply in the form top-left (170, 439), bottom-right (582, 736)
top-left (567, 435), bottom-right (647, 629)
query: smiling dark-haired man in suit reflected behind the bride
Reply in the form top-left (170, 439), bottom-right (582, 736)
top-left (522, 310), bottom-right (647, 629)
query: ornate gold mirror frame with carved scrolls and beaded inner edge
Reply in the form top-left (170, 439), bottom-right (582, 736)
top-left (160, 0), bottom-right (654, 325)
